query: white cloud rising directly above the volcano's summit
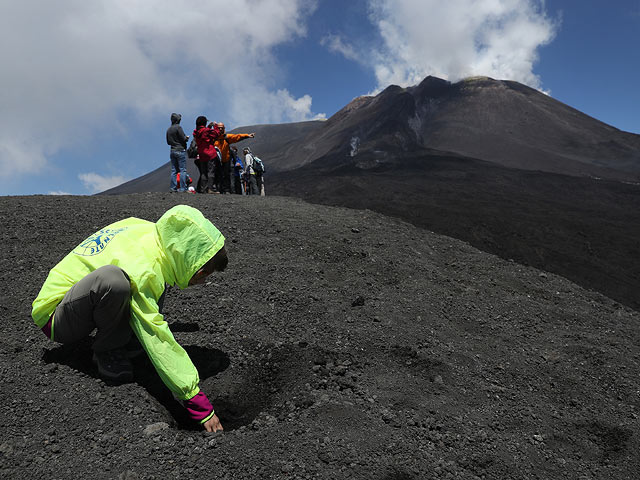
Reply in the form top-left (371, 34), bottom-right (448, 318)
top-left (336, 0), bottom-right (557, 88)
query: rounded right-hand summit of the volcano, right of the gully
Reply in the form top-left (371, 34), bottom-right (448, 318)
top-left (413, 79), bottom-right (640, 181)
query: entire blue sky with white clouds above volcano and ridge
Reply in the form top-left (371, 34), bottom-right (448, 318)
top-left (0, 0), bottom-right (640, 195)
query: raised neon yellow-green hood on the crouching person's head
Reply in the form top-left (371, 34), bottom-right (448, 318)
top-left (156, 205), bottom-right (224, 288)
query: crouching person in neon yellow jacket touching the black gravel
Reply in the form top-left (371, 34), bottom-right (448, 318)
top-left (31, 205), bottom-right (228, 432)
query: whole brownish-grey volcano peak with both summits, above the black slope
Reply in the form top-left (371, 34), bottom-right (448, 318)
top-left (251, 77), bottom-right (640, 181)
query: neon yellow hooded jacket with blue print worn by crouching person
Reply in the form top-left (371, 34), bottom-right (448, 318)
top-left (31, 205), bottom-right (224, 400)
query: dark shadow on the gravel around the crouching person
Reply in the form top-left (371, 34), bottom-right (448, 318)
top-left (42, 338), bottom-right (230, 430)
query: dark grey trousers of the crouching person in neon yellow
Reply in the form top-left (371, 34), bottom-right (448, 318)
top-left (53, 265), bottom-right (132, 352)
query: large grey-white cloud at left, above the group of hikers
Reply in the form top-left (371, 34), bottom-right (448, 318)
top-left (0, 0), bottom-right (317, 180)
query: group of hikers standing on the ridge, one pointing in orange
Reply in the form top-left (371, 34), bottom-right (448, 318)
top-left (167, 113), bottom-right (265, 195)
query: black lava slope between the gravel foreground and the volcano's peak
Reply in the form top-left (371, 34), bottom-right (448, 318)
top-left (268, 152), bottom-right (640, 309)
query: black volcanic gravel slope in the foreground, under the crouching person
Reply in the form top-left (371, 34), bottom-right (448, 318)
top-left (0, 194), bottom-right (640, 480)
